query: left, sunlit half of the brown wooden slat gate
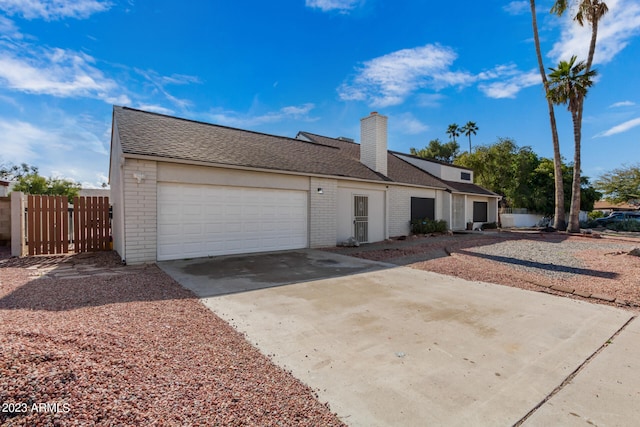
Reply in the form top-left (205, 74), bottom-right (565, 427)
top-left (27, 196), bottom-right (69, 255)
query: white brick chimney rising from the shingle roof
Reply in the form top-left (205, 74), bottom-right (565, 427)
top-left (360, 111), bottom-right (387, 175)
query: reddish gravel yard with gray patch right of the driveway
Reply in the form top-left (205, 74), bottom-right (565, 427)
top-left (331, 232), bottom-right (640, 310)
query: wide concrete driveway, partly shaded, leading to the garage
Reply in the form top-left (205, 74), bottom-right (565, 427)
top-left (159, 250), bottom-right (640, 426)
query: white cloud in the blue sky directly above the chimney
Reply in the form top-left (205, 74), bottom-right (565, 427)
top-left (338, 44), bottom-right (475, 107)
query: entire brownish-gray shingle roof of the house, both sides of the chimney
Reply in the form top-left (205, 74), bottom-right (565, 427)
top-left (113, 106), bottom-right (494, 195)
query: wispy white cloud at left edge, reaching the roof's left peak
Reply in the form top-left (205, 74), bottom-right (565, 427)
top-left (0, 45), bottom-right (130, 103)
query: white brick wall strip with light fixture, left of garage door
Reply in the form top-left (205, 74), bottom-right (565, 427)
top-left (123, 159), bottom-right (157, 264)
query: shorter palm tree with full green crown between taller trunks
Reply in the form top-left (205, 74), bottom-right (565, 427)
top-left (547, 56), bottom-right (597, 233)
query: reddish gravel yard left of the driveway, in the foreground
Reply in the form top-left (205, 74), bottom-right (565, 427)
top-left (0, 260), bottom-right (343, 426)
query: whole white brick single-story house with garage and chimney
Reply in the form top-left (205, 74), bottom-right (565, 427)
top-left (109, 106), bottom-right (500, 264)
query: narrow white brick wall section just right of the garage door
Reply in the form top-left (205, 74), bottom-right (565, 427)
top-left (309, 177), bottom-right (338, 248)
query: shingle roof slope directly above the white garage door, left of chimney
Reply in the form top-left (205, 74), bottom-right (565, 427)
top-left (113, 107), bottom-right (385, 181)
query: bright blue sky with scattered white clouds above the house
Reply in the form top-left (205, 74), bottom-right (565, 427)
top-left (0, 0), bottom-right (640, 186)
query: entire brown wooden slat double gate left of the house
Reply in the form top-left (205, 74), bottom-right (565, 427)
top-left (26, 195), bottom-right (111, 255)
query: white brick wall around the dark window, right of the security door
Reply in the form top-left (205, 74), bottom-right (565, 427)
top-left (389, 186), bottom-right (442, 237)
